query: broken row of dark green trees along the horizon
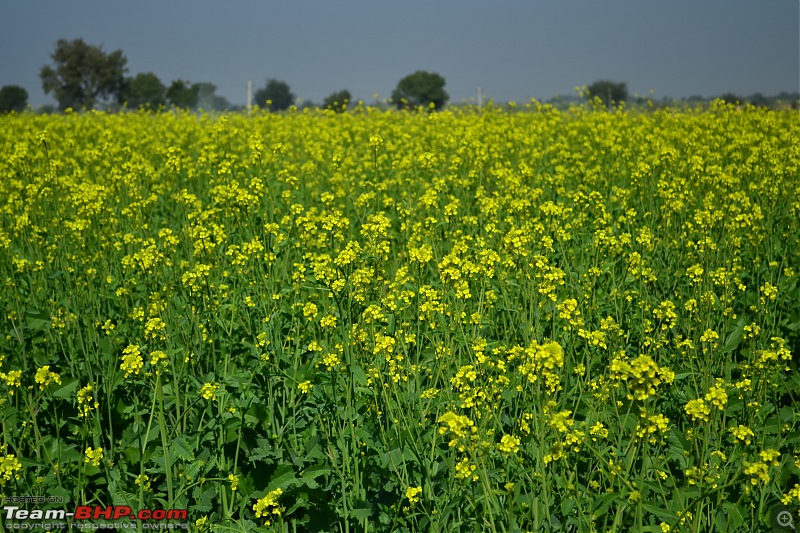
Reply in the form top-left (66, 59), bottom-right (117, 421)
top-left (0, 39), bottom-right (800, 112)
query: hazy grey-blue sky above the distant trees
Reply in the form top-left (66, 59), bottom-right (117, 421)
top-left (0, 0), bottom-right (800, 106)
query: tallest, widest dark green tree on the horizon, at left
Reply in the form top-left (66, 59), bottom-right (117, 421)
top-left (39, 39), bottom-right (128, 110)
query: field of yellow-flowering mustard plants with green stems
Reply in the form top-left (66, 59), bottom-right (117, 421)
top-left (0, 102), bottom-right (800, 533)
